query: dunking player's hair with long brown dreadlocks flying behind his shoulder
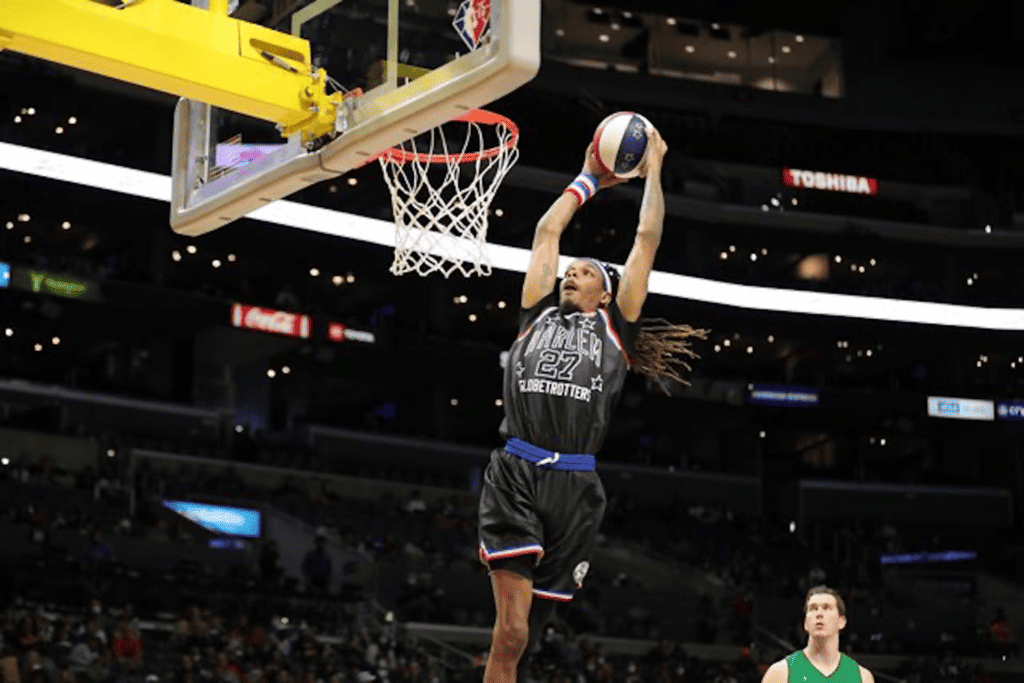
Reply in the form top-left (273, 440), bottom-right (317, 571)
top-left (585, 258), bottom-right (711, 393)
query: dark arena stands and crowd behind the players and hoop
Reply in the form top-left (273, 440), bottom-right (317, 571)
top-left (0, 0), bottom-right (1024, 683)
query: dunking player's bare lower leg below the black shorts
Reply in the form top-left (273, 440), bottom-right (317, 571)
top-left (483, 569), bottom-right (534, 683)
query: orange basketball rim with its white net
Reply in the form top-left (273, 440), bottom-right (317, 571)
top-left (378, 110), bottom-right (519, 278)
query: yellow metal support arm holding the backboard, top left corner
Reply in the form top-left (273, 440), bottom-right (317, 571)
top-left (0, 0), bottom-right (341, 137)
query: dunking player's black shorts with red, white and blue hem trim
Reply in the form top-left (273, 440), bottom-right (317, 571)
top-left (479, 449), bottom-right (606, 601)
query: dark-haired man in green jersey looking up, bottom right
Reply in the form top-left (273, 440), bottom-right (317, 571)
top-left (761, 586), bottom-right (874, 683)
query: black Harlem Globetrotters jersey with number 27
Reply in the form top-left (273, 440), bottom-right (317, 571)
top-left (501, 293), bottom-right (639, 454)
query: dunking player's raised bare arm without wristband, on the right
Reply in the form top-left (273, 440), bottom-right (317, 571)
top-left (615, 128), bottom-right (668, 323)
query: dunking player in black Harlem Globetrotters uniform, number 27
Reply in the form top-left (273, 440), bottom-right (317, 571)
top-left (479, 129), bottom-right (705, 683)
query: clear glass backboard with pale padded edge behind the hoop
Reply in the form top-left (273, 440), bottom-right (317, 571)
top-left (170, 0), bottom-right (541, 236)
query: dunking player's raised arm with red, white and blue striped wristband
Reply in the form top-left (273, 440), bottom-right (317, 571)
top-left (521, 144), bottom-right (624, 308)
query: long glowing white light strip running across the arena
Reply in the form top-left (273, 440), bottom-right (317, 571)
top-left (6, 142), bottom-right (1024, 332)
